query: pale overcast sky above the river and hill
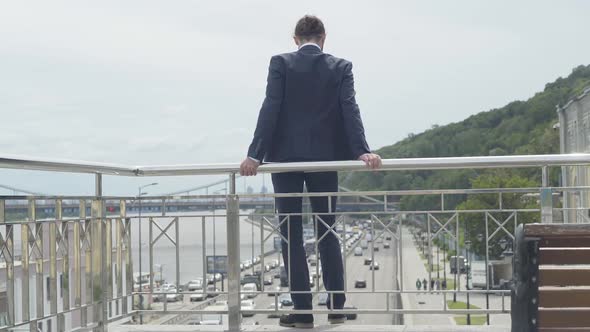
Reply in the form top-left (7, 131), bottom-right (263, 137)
top-left (0, 0), bottom-right (590, 194)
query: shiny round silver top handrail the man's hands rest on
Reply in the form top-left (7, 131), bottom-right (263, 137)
top-left (0, 153), bottom-right (590, 176)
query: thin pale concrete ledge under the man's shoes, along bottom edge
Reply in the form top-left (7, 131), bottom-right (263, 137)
top-left (109, 324), bottom-right (510, 332)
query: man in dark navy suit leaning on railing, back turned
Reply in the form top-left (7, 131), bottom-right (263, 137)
top-left (240, 15), bottom-right (381, 328)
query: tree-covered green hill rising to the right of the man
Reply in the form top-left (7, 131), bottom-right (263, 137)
top-left (341, 66), bottom-right (590, 210)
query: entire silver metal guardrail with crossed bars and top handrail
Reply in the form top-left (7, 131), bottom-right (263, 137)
top-left (0, 154), bottom-right (590, 331)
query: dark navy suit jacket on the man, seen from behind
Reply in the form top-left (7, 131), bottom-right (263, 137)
top-left (248, 45), bottom-right (370, 162)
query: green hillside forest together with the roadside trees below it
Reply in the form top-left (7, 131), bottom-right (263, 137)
top-left (341, 66), bottom-right (590, 257)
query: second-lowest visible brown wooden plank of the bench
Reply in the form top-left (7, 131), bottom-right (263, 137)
top-left (539, 287), bottom-right (590, 308)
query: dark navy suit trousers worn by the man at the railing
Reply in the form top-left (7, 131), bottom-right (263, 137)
top-left (272, 172), bottom-right (346, 309)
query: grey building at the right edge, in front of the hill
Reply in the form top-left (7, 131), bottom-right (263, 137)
top-left (557, 87), bottom-right (590, 223)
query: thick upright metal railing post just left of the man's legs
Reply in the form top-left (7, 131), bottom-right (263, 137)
top-left (226, 173), bottom-right (241, 331)
